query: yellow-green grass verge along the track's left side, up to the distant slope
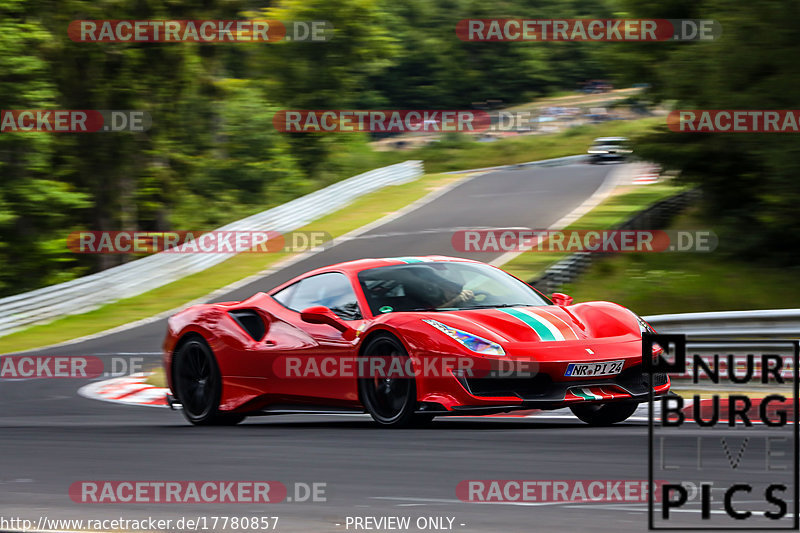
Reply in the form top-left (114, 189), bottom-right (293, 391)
top-left (0, 119), bottom-right (659, 354)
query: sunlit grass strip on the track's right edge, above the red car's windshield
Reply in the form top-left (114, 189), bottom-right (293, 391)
top-left (503, 182), bottom-right (683, 281)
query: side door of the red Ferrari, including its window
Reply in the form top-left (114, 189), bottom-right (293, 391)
top-left (265, 272), bottom-right (363, 406)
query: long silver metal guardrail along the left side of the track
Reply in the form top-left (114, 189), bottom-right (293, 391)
top-left (0, 161), bottom-right (423, 336)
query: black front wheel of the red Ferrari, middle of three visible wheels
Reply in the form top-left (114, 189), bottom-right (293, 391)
top-left (358, 334), bottom-right (433, 428)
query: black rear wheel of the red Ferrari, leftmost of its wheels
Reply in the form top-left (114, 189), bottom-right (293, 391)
top-left (172, 336), bottom-right (245, 426)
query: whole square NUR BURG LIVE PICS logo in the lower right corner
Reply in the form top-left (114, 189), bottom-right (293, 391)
top-left (642, 333), bottom-right (800, 531)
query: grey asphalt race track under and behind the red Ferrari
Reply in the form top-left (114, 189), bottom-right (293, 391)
top-left (0, 164), bottom-right (792, 532)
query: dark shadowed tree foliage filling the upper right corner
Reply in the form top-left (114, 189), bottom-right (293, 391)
top-left (608, 0), bottom-right (800, 264)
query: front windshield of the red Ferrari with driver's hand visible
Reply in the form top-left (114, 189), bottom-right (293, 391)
top-left (358, 262), bottom-right (550, 315)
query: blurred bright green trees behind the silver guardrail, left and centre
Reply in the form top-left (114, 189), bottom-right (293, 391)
top-left (0, 0), bottom-right (632, 296)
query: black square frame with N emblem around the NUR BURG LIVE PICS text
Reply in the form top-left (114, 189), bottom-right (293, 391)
top-left (642, 332), bottom-right (800, 531)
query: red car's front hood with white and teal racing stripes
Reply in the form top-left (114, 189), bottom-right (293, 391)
top-left (410, 302), bottom-right (640, 343)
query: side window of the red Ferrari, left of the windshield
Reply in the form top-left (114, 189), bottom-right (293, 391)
top-left (275, 272), bottom-right (361, 320)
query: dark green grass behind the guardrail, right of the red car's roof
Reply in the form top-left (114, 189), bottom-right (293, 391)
top-left (563, 212), bottom-right (800, 315)
